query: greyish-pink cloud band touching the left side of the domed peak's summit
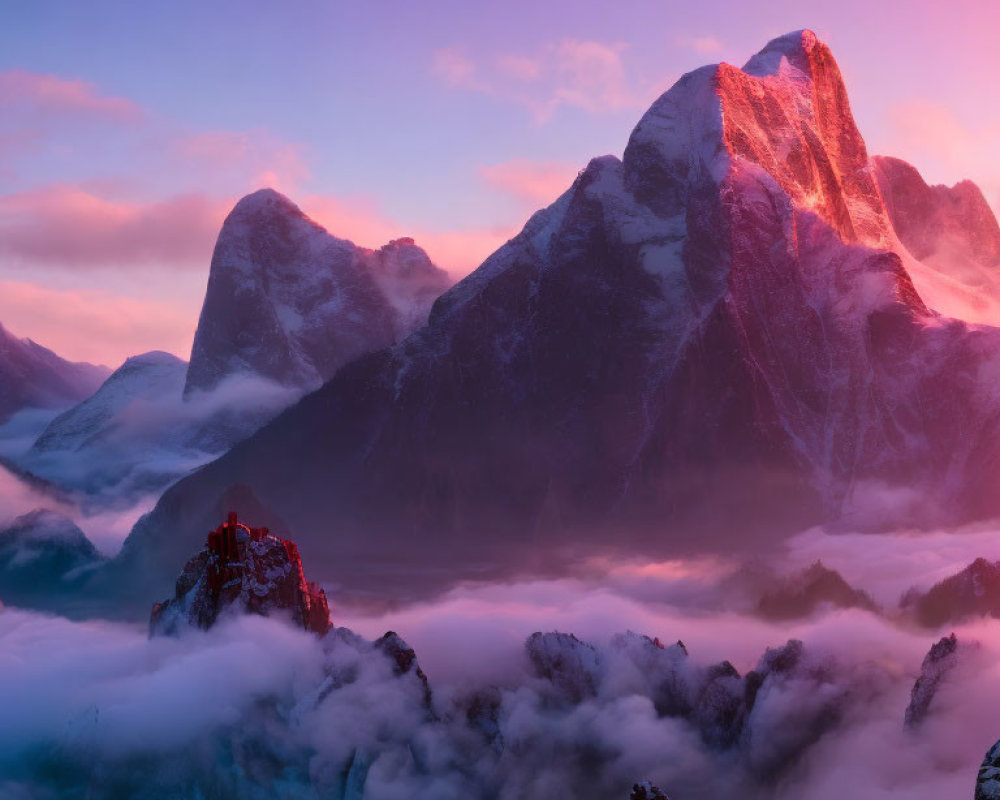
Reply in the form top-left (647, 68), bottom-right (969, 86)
top-left (0, 184), bottom-right (228, 269)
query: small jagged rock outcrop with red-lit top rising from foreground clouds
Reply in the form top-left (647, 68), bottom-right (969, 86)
top-left (149, 512), bottom-right (330, 635)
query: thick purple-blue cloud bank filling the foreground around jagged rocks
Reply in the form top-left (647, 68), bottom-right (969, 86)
top-left (0, 580), bottom-right (1000, 800)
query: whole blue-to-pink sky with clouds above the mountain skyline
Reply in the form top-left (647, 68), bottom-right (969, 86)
top-left (0, 0), bottom-right (1000, 366)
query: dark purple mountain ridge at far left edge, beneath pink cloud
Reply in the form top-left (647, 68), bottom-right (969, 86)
top-left (0, 325), bottom-right (110, 423)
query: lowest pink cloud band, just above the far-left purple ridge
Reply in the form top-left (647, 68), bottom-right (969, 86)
top-left (0, 280), bottom-right (197, 366)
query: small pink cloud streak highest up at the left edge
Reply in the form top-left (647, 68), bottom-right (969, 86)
top-left (0, 70), bottom-right (143, 122)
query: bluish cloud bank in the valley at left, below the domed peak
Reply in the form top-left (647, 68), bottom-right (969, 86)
top-left (0, 362), bottom-right (302, 556)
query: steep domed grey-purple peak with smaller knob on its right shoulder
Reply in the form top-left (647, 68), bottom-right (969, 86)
top-left (184, 189), bottom-right (450, 396)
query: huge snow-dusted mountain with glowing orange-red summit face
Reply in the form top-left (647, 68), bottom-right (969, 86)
top-left (84, 31), bottom-right (1000, 599)
